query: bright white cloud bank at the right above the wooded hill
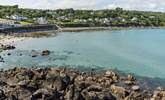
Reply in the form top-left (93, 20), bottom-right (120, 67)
top-left (104, 0), bottom-right (165, 11)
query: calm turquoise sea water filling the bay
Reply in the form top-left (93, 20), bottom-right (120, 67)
top-left (0, 29), bottom-right (165, 79)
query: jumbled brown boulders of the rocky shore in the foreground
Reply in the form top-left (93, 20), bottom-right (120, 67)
top-left (0, 68), bottom-right (165, 100)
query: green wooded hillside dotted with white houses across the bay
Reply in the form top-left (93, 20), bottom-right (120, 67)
top-left (0, 5), bottom-right (165, 27)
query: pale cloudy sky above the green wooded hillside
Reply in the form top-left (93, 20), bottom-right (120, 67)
top-left (0, 0), bottom-right (165, 12)
